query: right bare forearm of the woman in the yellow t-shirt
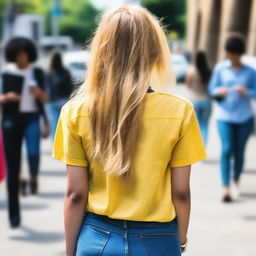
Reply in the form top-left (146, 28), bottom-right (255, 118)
top-left (171, 165), bottom-right (191, 244)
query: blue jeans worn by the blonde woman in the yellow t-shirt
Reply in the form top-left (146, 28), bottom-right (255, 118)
top-left (76, 213), bottom-right (181, 256)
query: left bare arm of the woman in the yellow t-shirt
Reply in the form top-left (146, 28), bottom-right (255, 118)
top-left (64, 165), bottom-right (88, 256)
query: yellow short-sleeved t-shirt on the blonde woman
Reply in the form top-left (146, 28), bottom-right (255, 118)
top-left (53, 92), bottom-right (206, 222)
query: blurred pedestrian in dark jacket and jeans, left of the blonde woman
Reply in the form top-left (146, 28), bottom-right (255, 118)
top-left (47, 51), bottom-right (72, 138)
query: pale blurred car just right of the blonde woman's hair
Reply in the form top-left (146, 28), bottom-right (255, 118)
top-left (172, 54), bottom-right (189, 83)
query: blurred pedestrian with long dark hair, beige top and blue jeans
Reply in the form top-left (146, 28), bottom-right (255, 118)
top-left (186, 51), bottom-right (212, 145)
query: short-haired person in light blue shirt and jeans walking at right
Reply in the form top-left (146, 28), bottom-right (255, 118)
top-left (209, 36), bottom-right (256, 202)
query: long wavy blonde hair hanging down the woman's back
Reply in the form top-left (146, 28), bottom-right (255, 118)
top-left (76, 5), bottom-right (171, 176)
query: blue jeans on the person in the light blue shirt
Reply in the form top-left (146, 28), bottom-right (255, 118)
top-left (217, 118), bottom-right (254, 186)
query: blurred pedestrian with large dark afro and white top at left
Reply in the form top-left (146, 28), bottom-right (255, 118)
top-left (1, 37), bottom-right (47, 227)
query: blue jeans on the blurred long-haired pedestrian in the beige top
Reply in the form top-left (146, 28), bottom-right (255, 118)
top-left (193, 100), bottom-right (212, 145)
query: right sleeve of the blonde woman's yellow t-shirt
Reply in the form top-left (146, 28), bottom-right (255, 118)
top-left (170, 106), bottom-right (207, 168)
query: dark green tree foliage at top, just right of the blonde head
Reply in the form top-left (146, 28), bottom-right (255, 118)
top-left (142, 0), bottom-right (186, 37)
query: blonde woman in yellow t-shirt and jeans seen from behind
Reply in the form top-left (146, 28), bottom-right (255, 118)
top-left (53, 6), bottom-right (206, 256)
